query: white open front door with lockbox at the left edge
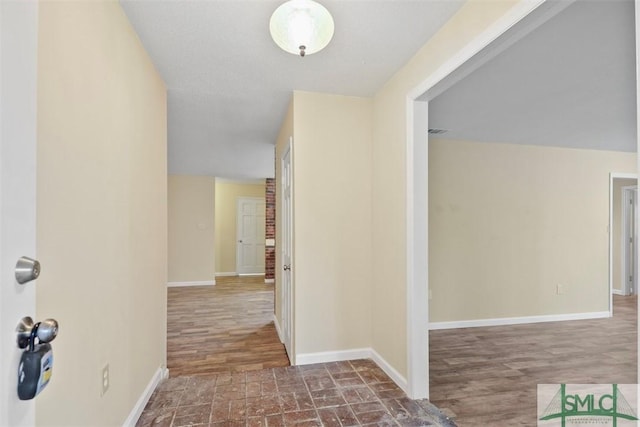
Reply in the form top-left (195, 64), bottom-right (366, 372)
top-left (0, 1), bottom-right (38, 426)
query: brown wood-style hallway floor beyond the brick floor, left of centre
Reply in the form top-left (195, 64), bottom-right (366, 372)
top-left (167, 276), bottom-right (289, 377)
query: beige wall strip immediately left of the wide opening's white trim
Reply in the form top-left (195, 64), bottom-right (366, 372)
top-left (371, 0), bottom-right (524, 382)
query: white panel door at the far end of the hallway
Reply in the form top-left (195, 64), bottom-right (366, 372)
top-left (236, 197), bottom-right (266, 274)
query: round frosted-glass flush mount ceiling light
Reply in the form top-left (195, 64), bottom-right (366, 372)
top-left (269, 0), bottom-right (334, 56)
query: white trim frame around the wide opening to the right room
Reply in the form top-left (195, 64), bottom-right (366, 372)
top-left (405, 0), bottom-right (584, 399)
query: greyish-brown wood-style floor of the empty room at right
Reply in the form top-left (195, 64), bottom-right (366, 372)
top-left (429, 295), bottom-right (638, 427)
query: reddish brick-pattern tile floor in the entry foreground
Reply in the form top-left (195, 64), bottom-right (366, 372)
top-left (137, 360), bottom-right (455, 427)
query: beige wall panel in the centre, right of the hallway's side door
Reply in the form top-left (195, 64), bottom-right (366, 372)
top-left (276, 92), bottom-right (371, 362)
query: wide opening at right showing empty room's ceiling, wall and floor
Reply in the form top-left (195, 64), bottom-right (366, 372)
top-left (414, 1), bottom-right (637, 425)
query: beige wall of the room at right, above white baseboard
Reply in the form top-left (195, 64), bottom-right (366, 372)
top-left (429, 139), bottom-right (636, 322)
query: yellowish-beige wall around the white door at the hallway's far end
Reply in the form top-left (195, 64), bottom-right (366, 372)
top-left (215, 179), bottom-right (265, 274)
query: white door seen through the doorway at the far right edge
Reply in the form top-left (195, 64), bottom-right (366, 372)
top-left (622, 187), bottom-right (638, 295)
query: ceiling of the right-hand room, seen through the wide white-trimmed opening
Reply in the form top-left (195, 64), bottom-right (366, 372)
top-left (429, 0), bottom-right (636, 152)
